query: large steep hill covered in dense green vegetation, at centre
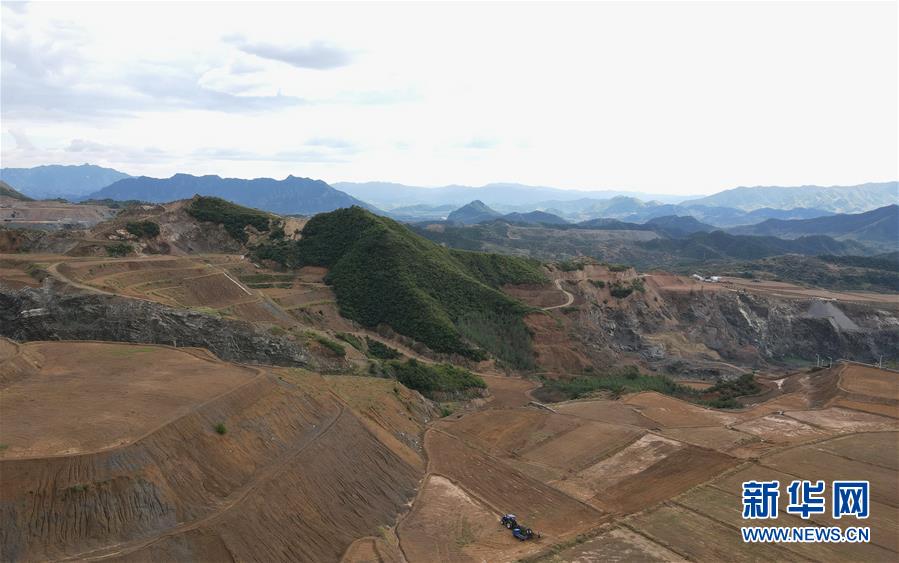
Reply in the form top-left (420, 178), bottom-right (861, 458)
top-left (253, 207), bottom-right (546, 367)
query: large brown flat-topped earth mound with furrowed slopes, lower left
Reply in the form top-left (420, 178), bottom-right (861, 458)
top-left (0, 342), bottom-right (421, 561)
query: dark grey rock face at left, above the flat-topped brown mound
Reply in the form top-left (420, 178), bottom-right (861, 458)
top-left (0, 286), bottom-right (316, 367)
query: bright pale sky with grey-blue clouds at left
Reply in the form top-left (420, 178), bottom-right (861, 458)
top-left (0, 1), bottom-right (899, 194)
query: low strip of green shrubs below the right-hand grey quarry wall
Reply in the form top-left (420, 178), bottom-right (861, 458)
top-left (536, 366), bottom-right (698, 401)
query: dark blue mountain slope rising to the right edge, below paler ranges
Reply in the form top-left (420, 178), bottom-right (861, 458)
top-left (730, 205), bottom-right (899, 252)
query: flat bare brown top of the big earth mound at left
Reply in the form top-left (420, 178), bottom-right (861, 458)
top-left (0, 342), bottom-right (257, 459)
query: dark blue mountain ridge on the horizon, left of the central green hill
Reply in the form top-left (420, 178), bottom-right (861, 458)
top-left (87, 174), bottom-right (372, 215)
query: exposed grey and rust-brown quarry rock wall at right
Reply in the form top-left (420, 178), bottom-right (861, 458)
top-left (566, 280), bottom-right (899, 376)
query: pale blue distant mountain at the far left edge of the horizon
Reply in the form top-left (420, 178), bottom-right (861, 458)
top-left (0, 164), bottom-right (130, 199)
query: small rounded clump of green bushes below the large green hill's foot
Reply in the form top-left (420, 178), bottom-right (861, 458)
top-left (383, 358), bottom-right (487, 400)
